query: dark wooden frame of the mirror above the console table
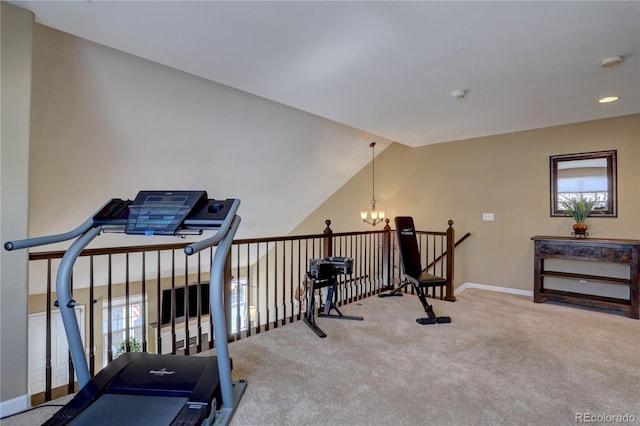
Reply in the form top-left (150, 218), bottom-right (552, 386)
top-left (549, 150), bottom-right (618, 217)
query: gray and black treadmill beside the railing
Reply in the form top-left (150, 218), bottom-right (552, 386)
top-left (4, 191), bottom-right (247, 426)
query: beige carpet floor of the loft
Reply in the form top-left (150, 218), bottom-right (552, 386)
top-left (2, 289), bottom-right (640, 426)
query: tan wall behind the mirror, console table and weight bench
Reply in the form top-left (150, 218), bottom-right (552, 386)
top-left (294, 115), bottom-right (640, 290)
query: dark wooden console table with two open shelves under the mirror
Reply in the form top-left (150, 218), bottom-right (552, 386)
top-left (531, 236), bottom-right (640, 319)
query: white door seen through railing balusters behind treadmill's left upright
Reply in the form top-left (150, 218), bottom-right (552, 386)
top-left (28, 305), bottom-right (85, 395)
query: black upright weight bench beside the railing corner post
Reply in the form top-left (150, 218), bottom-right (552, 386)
top-left (378, 216), bottom-right (451, 325)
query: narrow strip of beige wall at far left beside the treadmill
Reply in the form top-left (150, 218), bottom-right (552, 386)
top-left (0, 2), bottom-right (33, 410)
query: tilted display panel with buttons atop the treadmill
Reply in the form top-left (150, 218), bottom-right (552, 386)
top-left (125, 191), bottom-right (207, 235)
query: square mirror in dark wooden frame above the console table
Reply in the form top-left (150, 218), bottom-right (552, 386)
top-left (550, 150), bottom-right (618, 217)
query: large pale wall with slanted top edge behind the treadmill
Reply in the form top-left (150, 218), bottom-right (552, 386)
top-left (30, 25), bottom-right (390, 245)
